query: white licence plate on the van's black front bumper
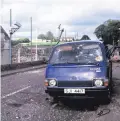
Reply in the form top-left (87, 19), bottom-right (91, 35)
top-left (64, 89), bottom-right (85, 94)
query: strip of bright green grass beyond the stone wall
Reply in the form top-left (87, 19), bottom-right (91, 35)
top-left (22, 42), bottom-right (64, 46)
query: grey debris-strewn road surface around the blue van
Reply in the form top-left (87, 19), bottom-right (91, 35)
top-left (1, 64), bottom-right (120, 121)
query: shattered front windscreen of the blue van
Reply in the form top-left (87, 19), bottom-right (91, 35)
top-left (50, 43), bottom-right (103, 64)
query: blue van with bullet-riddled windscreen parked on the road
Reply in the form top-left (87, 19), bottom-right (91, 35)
top-left (45, 40), bottom-right (112, 100)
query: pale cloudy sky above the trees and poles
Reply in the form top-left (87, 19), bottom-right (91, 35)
top-left (0, 0), bottom-right (120, 39)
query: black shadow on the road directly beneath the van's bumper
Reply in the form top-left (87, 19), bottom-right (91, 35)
top-left (50, 99), bottom-right (108, 111)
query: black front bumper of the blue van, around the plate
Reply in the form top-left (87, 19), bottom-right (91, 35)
top-left (45, 87), bottom-right (110, 98)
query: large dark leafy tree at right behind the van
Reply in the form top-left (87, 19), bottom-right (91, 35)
top-left (94, 20), bottom-right (120, 44)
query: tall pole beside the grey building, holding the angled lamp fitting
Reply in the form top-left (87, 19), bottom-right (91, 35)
top-left (9, 9), bottom-right (12, 64)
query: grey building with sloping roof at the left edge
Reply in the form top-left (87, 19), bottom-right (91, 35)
top-left (0, 26), bottom-right (10, 65)
